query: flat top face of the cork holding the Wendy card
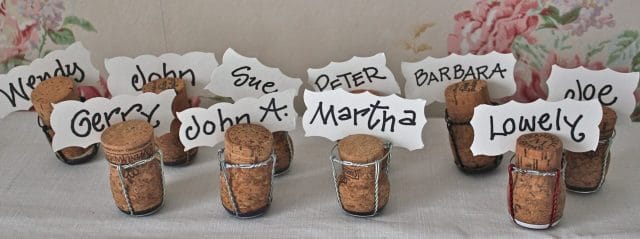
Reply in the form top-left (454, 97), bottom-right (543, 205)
top-left (31, 76), bottom-right (73, 104)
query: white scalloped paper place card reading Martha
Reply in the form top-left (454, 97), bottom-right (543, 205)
top-left (302, 89), bottom-right (427, 150)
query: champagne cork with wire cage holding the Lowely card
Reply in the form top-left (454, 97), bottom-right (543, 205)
top-left (509, 133), bottom-right (565, 229)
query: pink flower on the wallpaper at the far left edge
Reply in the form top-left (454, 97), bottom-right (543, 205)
top-left (0, 15), bottom-right (38, 62)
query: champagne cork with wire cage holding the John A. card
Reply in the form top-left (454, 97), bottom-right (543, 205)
top-left (220, 124), bottom-right (274, 217)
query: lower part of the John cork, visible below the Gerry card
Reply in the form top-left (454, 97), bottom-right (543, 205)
top-left (156, 119), bottom-right (198, 166)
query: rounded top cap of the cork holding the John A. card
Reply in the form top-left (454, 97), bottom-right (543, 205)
top-left (224, 124), bottom-right (273, 163)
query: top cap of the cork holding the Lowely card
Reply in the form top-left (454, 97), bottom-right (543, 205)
top-left (516, 133), bottom-right (563, 170)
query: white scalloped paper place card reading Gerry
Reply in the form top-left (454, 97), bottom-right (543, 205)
top-left (51, 90), bottom-right (176, 151)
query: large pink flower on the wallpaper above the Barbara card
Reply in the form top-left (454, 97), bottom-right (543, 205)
top-left (447, 0), bottom-right (538, 55)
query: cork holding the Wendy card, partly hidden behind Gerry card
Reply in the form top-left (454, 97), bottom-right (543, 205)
top-left (31, 76), bottom-right (97, 164)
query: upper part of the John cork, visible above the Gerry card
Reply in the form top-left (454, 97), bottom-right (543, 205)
top-left (142, 78), bottom-right (190, 116)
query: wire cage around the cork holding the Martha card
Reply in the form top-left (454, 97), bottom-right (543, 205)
top-left (329, 142), bottom-right (393, 217)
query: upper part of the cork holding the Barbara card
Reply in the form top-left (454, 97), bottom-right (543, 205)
top-left (444, 80), bottom-right (491, 122)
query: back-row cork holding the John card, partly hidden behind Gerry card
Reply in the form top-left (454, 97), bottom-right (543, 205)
top-left (142, 78), bottom-right (198, 166)
